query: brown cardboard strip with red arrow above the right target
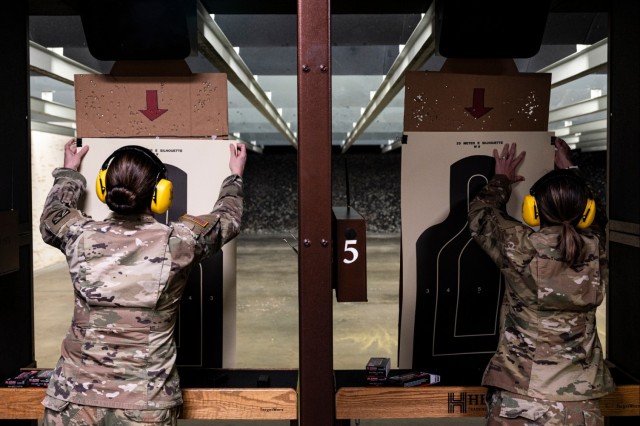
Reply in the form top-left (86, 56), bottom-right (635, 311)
top-left (404, 68), bottom-right (551, 132)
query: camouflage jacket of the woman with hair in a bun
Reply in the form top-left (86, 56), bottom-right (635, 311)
top-left (40, 168), bottom-right (243, 409)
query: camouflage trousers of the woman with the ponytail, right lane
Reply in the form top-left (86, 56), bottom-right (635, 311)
top-left (487, 388), bottom-right (604, 426)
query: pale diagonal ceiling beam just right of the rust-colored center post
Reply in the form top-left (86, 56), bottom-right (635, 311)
top-left (342, 0), bottom-right (436, 154)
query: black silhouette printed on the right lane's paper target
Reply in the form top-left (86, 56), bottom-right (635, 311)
top-left (412, 155), bottom-right (503, 383)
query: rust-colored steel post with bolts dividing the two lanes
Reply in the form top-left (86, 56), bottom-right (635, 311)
top-left (298, 0), bottom-right (335, 426)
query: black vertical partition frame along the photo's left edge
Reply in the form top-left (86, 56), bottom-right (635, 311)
top-left (0, 2), bottom-right (35, 380)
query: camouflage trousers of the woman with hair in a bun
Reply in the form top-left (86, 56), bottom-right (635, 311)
top-left (42, 403), bottom-right (180, 426)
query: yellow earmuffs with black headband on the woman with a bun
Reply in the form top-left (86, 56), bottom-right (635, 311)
top-left (96, 145), bottom-right (173, 214)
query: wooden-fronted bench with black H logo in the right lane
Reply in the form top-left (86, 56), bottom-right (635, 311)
top-left (335, 370), bottom-right (640, 426)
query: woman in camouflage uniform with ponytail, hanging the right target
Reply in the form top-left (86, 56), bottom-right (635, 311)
top-left (469, 138), bottom-right (614, 426)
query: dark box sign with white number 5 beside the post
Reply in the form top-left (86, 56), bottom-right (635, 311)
top-left (332, 207), bottom-right (367, 302)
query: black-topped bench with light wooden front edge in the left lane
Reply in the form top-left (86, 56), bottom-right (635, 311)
top-left (0, 369), bottom-right (298, 426)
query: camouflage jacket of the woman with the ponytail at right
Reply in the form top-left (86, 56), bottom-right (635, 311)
top-left (469, 175), bottom-right (614, 401)
